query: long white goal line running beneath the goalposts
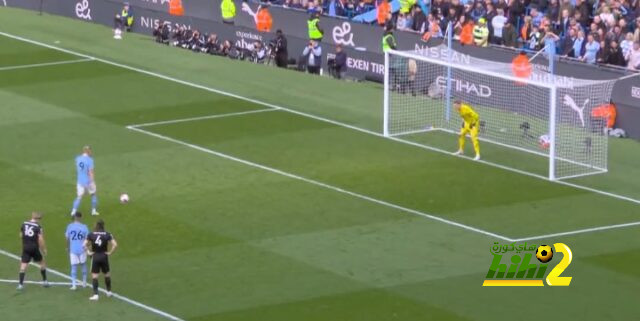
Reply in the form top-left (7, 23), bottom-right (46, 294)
top-left (0, 32), bottom-right (640, 241)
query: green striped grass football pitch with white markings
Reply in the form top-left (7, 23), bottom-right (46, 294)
top-left (0, 7), bottom-right (640, 321)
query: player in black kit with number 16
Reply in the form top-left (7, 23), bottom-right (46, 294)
top-left (18, 212), bottom-right (49, 290)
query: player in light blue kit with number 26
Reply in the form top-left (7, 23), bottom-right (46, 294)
top-left (64, 212), bottom-right (89, 290)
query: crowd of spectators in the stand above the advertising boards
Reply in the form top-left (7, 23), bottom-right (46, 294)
top-left (270, 0), bottom-right (640, 70)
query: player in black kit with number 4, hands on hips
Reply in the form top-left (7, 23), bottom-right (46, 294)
top-left (84, 220), bottom-right (118, 301)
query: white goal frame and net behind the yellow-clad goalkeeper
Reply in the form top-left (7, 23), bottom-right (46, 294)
top-left (383, 46), bottom-right (615, 180)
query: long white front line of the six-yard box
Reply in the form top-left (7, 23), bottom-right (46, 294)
top-left (127, 126), bottom-right (513, 242)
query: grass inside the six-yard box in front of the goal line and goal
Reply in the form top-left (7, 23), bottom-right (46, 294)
top-left (146, 113), bottom-right (636, 237)
